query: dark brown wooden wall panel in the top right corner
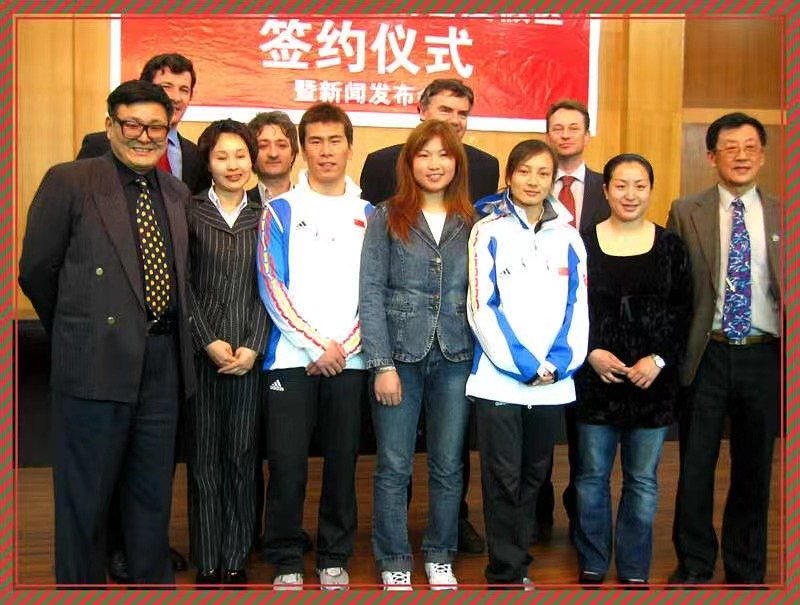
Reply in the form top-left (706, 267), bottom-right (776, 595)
top-left (684, 17), bottom-right (783, 108)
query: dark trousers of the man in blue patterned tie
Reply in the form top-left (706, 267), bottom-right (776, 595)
top-left (673, 341), bottom-right (780, 583)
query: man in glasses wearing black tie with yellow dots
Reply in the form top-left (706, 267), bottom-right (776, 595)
top-left (19, 80), bottom-right (194, 584)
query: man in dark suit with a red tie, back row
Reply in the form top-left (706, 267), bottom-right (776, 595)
top-left (536, 99), bottom-right (611, 542)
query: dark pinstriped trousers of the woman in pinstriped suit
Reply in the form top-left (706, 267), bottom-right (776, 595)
top-left (186, 356), bottom-right (261, 570)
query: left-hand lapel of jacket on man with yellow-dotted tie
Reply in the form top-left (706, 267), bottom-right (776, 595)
top-left (92, 156), bottom-right (145, 308)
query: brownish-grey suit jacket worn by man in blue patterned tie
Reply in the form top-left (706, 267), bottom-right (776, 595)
top-left (667, 185), bottom-right (781, 386)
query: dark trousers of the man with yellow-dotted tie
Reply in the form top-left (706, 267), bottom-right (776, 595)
top-left (53, 335), bottom-right (180, 584)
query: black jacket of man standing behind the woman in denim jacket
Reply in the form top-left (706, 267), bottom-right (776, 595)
top-left (361, 145), bottom-right (500, 204)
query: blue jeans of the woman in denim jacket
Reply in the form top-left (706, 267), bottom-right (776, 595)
top-left (370, 342), bottom-right (471, 571)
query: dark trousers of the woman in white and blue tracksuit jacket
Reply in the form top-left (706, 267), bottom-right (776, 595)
top-left (475, 399), bottom-right (563, 584)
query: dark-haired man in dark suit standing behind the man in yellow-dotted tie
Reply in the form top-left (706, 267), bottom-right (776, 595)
top-left (77, 53), bottom-right (211, 193)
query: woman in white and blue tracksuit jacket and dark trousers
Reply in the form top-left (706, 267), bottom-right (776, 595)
top-left (467, 139), bottom-right (589, 584)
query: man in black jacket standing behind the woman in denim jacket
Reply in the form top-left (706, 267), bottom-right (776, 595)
top-left (361, 78), bottom-right (500, 554)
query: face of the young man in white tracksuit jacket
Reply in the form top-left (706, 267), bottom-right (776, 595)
top-left (303, 122), bottom-right (353, 184)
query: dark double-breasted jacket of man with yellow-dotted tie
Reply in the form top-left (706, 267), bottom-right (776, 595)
top-left (19, 153), bottom-right (195, 402)
